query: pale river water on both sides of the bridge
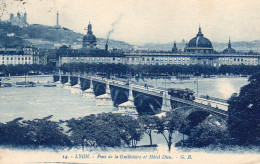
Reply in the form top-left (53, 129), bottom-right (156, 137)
top-left (0, 76), bottom-right (247, 122)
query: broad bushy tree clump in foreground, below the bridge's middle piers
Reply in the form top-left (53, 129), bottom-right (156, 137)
top-left (67, 113), bottom-right (142, 149)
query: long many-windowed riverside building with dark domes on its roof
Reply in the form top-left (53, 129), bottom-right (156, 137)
top-left (57, 24), bottom-right (260, 67)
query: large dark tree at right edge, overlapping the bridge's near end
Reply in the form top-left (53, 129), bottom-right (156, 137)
top-left (228, 72), bottom-right (260, 145)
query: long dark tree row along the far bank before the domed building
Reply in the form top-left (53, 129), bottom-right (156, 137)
top-left (60, 63), bottom-right (260, 77)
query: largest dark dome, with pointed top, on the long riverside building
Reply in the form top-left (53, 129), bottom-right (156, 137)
top-left (184, 27), bottom-right (213, 54)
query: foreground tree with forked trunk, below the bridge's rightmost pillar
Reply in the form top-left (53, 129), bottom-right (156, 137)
top-left (156, 111), bottom-right (188, 152)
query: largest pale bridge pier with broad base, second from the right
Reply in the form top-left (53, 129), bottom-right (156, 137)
top-left (118, 84), bottom-right (138, 115)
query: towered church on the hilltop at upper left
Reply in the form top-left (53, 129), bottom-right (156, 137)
top-left (8, 11), bottom-right (29, 28)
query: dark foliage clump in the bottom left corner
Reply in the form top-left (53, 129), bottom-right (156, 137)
top-left (0, 116), bottom-right (70, 148)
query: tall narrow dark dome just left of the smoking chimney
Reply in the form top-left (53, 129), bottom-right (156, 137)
top-left (82, 23), bottom-right (97, 49)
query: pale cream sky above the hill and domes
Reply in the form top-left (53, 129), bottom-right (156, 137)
top-left (0, 0), bottom-right (260, 45)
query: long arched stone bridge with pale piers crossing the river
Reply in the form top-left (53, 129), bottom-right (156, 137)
top-left (54, 75), bottom-right (227, 119)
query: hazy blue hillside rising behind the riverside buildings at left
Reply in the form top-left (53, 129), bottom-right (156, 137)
top-left (0, 22), bottom-right (133, 49)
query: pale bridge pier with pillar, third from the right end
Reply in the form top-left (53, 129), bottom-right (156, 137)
top-left (95, 79), bottom-right (113, 106)
